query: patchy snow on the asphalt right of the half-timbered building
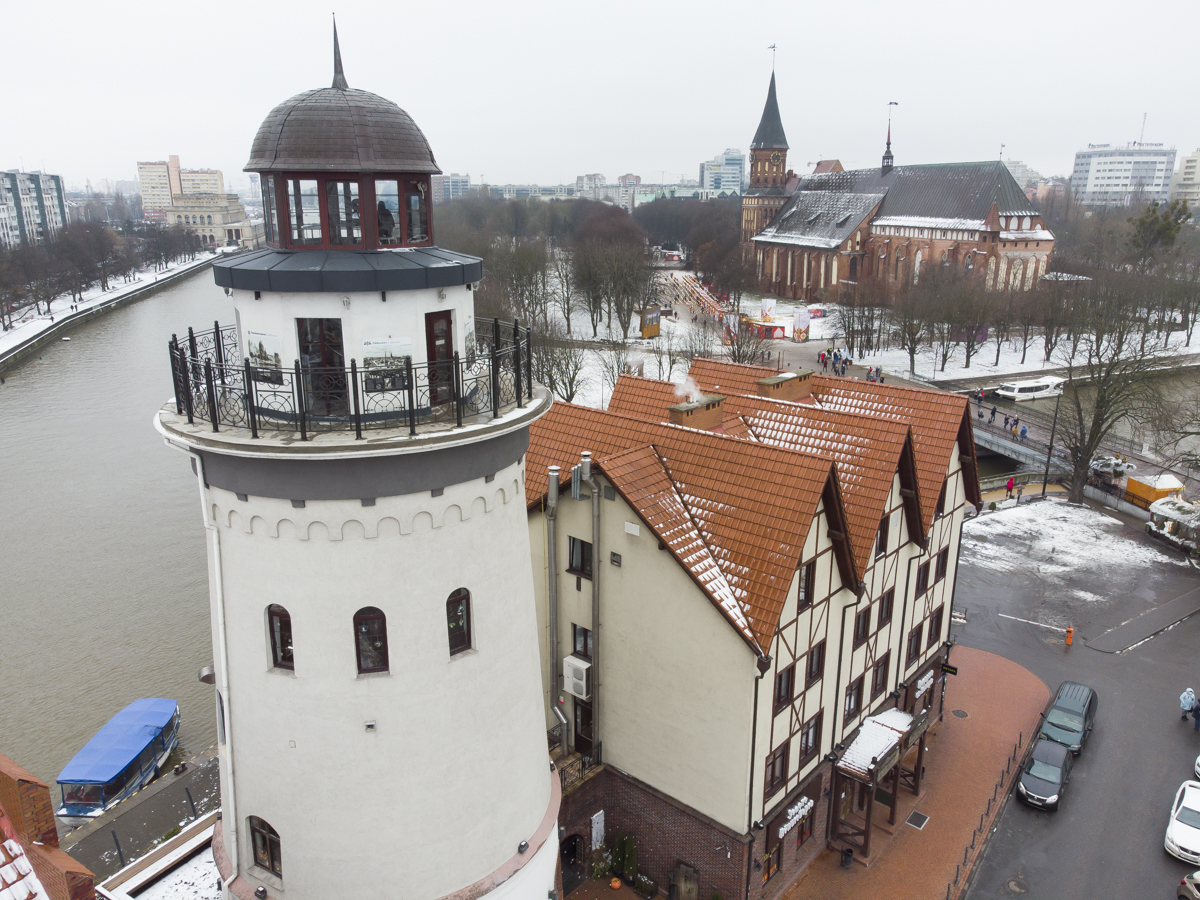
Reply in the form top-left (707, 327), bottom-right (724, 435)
top-left (962, 500), bottom-right (1188, 602)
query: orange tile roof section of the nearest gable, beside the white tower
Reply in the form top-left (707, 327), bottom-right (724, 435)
top-left (526, 403), bottom-right (858, 655)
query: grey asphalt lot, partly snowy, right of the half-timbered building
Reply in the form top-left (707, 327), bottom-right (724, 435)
top-left (954, 504), bottom-right (1200, 900)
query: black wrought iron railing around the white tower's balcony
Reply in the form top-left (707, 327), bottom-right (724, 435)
top-left (168, 319), bottom-right (533, 440)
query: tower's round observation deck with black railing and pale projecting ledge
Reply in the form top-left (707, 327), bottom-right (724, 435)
top-left (155, 319), bottom-right (552, 460)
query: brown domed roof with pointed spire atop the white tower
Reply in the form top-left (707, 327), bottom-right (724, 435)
top-left (245, 26), bottom-right (442, 174)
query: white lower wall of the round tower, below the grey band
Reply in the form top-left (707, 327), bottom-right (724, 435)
top-left (204, 461), bottom-right (557, 899)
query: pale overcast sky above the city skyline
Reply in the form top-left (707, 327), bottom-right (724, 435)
top-left (9, 0), bottom-right (1200, 194)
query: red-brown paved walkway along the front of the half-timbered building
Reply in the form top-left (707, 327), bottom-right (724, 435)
top-left (782, 646), bottom-right (1050, 900)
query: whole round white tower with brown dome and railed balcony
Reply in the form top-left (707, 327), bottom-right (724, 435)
top-left (155, 32), bottom-right (560, 900)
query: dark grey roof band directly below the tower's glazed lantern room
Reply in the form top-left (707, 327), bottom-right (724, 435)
top-left (212, 247), bottom-right (484, 294)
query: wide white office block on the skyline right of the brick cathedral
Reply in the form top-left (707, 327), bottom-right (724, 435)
top-left (1070, 142), bottom-right (1175, 206)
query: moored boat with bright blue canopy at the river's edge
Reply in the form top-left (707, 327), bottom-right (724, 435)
top-left (54, 697), bottom-right (179, 824)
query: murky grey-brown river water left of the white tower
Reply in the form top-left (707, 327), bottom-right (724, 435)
top-left (0, 270), bottom-right (225, 798)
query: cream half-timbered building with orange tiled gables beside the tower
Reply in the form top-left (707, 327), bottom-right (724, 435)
top-left (526, 360), bottom-right (979, 898)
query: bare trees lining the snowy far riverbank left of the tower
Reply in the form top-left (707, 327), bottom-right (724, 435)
top-left (0, 222), bottom-right (202, 331)
